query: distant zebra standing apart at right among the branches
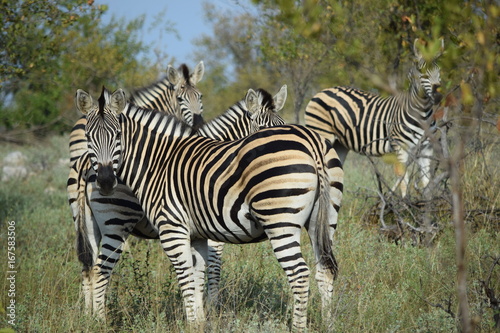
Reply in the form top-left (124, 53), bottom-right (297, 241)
top-left (305, 39), bottom-right (444, 197)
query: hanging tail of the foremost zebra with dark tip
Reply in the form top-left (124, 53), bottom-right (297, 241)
top-left (316, 163), bottom-right (338, 279)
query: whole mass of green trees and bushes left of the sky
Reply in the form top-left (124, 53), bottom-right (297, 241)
top-left (0, 0), bottom-right (170, 140)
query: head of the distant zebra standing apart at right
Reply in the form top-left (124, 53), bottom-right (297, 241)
top-left (410, 38), bottom-right (444, 105)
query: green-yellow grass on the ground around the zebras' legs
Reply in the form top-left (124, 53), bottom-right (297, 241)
top-left (0, 131), bottom-right (500, 332)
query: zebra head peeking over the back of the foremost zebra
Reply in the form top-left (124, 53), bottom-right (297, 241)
top-left (245, 84), bottom-right (287, 134)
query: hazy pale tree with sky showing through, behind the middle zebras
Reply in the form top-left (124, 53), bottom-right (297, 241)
top-left (196, 2), bottom-right (292, 119)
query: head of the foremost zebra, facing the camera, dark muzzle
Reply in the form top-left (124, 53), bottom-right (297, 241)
top-left (75, 87), bottom-right (127, 195)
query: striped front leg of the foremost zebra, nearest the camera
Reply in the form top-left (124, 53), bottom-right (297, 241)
top-left (158, 221), bottom-right (205, 324)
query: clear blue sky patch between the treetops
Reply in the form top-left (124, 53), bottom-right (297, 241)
top-left (95, 0), bottom-right (254, 68)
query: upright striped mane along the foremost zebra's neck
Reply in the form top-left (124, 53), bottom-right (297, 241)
top-left (121, 103), bottom-right (194, 136)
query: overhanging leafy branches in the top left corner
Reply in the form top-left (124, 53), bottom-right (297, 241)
top-left (0, 0), bottom-right (96, 85)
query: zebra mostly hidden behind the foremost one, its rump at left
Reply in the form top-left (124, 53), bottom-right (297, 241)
top-left (67, 61), bottom-right (204, 317)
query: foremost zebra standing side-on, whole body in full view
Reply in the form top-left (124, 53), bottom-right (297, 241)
top-left (75, 89), bottom-right (343, 330)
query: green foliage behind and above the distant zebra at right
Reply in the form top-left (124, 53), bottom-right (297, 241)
top-left (250, 0), bottom-right (500, 121)
